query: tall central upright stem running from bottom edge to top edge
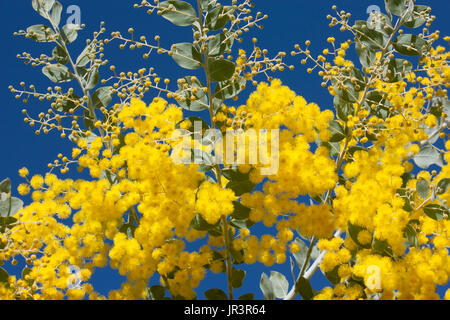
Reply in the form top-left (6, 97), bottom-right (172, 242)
top-left (197, 0), bottom-right (234, 300)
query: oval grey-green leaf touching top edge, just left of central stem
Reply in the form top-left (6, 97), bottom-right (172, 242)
top-left (159, 0), bottom-right (197, 27)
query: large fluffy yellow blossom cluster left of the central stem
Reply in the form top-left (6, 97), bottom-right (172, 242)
top-left (2, 99), bottom-right (215, 299)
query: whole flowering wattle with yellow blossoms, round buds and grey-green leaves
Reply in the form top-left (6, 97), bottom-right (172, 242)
top-left (0, 0), bottom-right (450, 300)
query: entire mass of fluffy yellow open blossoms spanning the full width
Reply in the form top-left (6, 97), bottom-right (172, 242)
top-left (0, 65), bottom-right (450, 299)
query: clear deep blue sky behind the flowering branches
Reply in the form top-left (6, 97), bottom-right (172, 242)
top-left (0, 0), bottom-right (450, 298)
